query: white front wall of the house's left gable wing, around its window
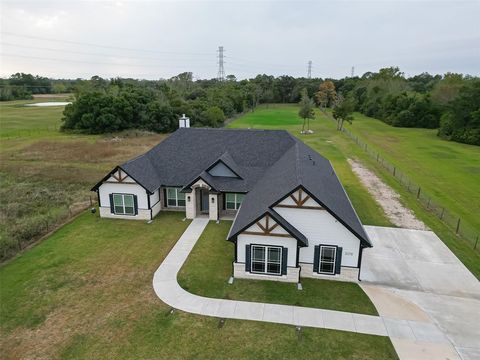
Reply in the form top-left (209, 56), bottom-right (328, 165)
top-left (98, 170), bottom-right (150, 220)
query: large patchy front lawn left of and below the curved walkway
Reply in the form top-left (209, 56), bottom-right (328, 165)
top-left (0, 213), bottom-right (397, 359)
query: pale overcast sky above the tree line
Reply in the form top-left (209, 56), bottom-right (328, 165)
top-left (0, 0), bottom-right (480, 79)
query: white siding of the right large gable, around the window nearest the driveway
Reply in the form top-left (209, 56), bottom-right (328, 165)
top-left (274, 198), bottom-right (360, 267)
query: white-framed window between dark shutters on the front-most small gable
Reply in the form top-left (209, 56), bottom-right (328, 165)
top-left (250, 245), bottom-right (282, 275)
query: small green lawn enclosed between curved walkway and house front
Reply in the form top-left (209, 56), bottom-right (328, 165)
top-left (178, 221), bottom-right (378, 315)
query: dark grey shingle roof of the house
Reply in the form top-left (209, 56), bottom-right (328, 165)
top-left (93, 128), bottom-right (370, 246)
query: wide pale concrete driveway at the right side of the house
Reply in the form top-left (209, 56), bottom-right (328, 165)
top-left (360, 226), bottom-right (480, 360)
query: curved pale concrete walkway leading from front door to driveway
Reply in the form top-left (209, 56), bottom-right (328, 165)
top-left (153, 218), bottom-right (455, 359)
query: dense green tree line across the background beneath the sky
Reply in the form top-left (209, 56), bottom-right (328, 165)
top-left (0, 67), bottom-right (480, 145)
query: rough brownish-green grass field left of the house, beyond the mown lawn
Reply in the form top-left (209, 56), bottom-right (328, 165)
top-left (0, 98), bottom-right (164, 259)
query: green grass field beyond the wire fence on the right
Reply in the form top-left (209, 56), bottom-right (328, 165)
top-left (346, 114), bottom-right (480, 240)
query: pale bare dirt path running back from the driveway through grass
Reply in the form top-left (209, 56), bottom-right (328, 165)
top-left (348, 159), bottom-right (429, 230)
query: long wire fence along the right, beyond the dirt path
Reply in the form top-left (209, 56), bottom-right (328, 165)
top-left (342, 128), bottom-right (480, 251)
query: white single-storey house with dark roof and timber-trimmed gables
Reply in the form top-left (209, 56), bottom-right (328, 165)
top-left (92, 128), bottom-right (371, 282)
